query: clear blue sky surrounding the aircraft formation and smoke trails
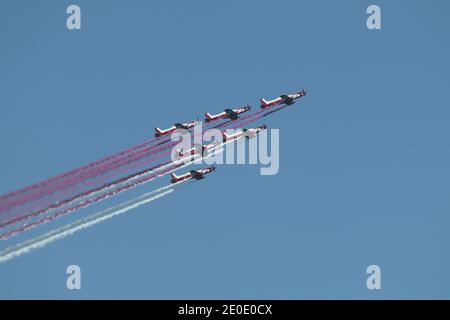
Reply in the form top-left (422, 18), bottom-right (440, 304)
top-left (0, 0), bottom-right (450, 299)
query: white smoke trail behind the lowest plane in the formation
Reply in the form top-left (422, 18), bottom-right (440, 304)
top-left (0, 182), bottom-right (187, 263)
